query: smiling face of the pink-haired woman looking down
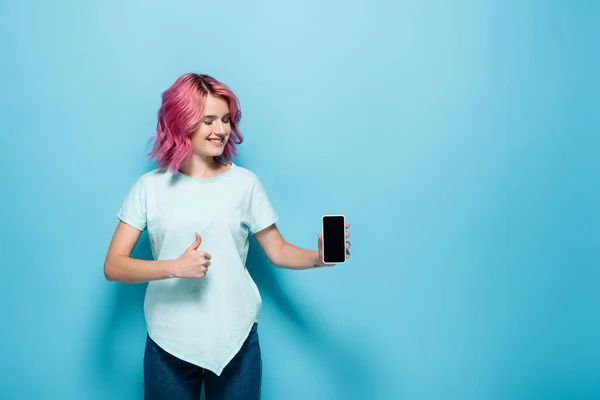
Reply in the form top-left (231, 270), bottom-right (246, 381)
top-left (192, 94), bottom-right (231, 157)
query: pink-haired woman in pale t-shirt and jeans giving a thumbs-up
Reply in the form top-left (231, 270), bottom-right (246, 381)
top-left (104, 74), bottom-right (350, 400)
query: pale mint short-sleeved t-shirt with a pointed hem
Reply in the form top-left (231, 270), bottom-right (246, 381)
top-left (117, 164), bottom-right (278, 375)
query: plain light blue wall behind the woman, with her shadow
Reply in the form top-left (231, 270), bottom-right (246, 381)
top-left (0, 0), bottom-right (600, 400)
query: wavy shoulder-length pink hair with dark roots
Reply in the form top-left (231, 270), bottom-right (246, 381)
top-left (148, 74), bottom-right (244, 172)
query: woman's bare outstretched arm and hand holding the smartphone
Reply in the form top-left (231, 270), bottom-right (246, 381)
top-left (254, 224), bottom-right (350, 270)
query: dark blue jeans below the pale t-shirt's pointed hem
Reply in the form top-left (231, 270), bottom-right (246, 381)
top-left (144, 324), bottom-right (262, 400)
